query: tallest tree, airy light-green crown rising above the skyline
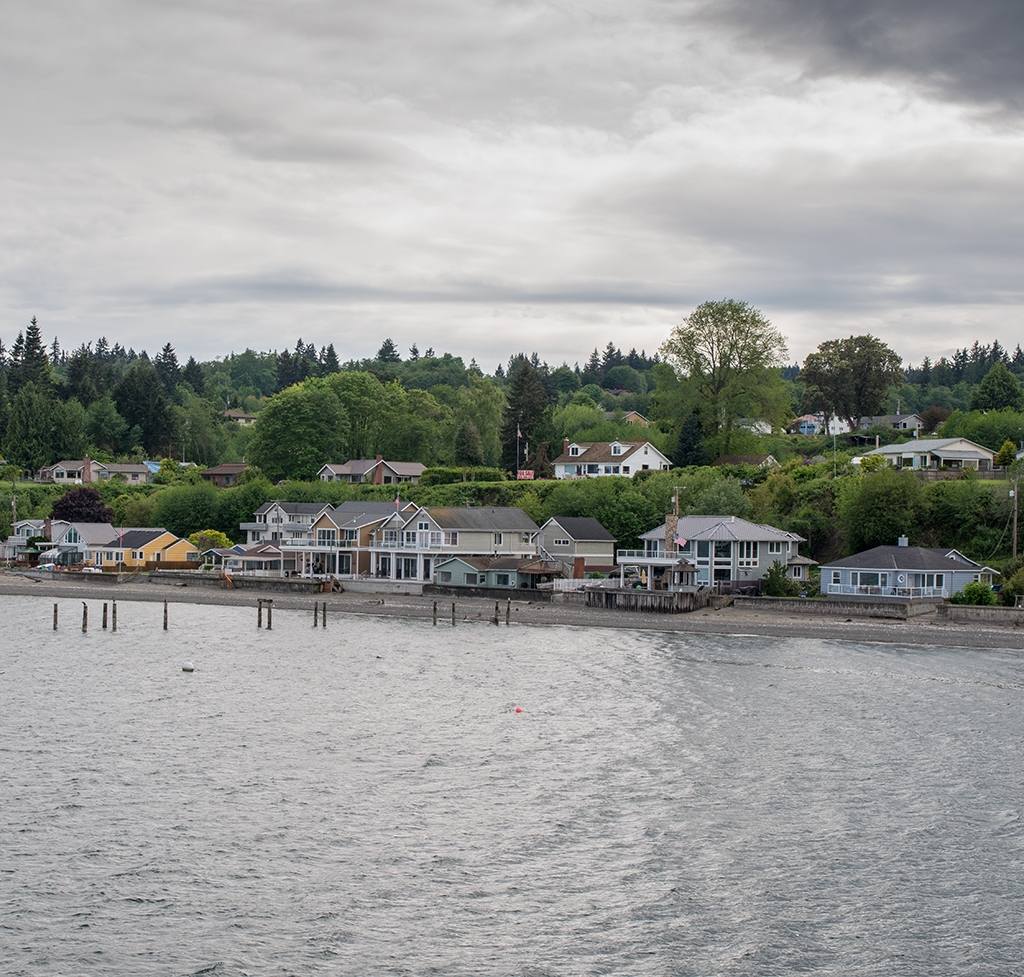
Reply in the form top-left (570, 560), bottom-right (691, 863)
top-left (660, 299), bottom-right (788, 451)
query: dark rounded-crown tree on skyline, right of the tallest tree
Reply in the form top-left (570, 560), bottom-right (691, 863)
top-left (800, 334), bottom-right (904, 429)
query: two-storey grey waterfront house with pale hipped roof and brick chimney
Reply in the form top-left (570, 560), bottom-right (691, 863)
top-left (616, 515), bottom-right (815, 591)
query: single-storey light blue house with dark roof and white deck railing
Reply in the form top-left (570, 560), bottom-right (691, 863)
top-left (821, 537), bottom-right (997, 600)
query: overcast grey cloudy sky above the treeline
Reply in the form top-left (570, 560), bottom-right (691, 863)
top-left (0, 0), bottom-right (1024, 372)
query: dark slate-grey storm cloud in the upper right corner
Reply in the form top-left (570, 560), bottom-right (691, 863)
top-left (701, 0), bottom-right (1024, 112)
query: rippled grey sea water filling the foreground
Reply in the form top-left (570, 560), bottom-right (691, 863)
top-left (0, 597), bottom-right (1024, 977)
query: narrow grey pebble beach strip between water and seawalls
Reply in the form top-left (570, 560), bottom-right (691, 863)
top-left (0, 574), bottom-right (1024, 650)
